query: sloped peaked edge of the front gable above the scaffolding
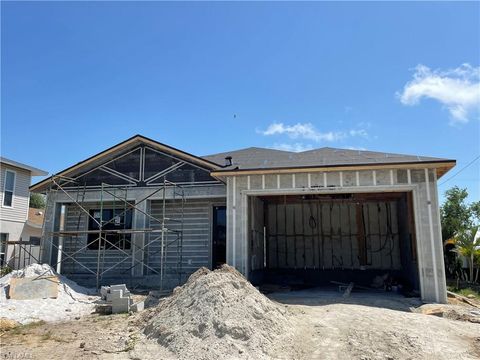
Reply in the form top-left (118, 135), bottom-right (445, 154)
top-left (30, 135), bottom-right (220, 192)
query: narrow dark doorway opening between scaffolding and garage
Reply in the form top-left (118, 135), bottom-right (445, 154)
top-left (212, 206), bottom-right (227, 269)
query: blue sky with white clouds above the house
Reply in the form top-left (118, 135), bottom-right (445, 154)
top-left (1, 2), bottom-right (480, 200)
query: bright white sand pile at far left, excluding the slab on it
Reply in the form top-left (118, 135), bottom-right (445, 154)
top-left (0, 264), bottom-right (99, 324)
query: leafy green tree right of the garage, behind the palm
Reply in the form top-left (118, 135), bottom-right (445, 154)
top-left (440, 186), bottom-right (480, 240)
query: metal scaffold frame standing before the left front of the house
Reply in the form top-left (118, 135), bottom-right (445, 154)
top-left (40, 175), bottom-right (185, 290)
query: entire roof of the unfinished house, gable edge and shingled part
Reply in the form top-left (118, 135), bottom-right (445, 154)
top-left (28, 135), bottom-right (456, 191)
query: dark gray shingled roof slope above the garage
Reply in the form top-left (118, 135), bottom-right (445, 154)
top-left (203, 147), bottom-right (452, 170)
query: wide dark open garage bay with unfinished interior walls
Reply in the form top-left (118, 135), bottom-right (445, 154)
top-left (249, 193), bottom-right (419, 295)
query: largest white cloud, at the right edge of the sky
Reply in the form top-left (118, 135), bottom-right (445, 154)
top-left (397, 64), bottom-right (480, 123)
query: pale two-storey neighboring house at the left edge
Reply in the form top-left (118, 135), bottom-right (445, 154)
top-left (0, 157), bottom-right (48, 266)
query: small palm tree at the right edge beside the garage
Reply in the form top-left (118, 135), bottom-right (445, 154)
top-left (454, 226), bottom-right (480, 283)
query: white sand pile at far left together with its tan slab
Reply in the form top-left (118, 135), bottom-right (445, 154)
top-left (0, 264), bottom-right (99, 324)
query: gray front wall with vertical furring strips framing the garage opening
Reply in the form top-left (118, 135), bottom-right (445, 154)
top-left (226, 169), bottom-right (446, 303)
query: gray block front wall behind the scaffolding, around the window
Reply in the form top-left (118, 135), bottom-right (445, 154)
top-left (58, 199), bottom-right (225, 283)
